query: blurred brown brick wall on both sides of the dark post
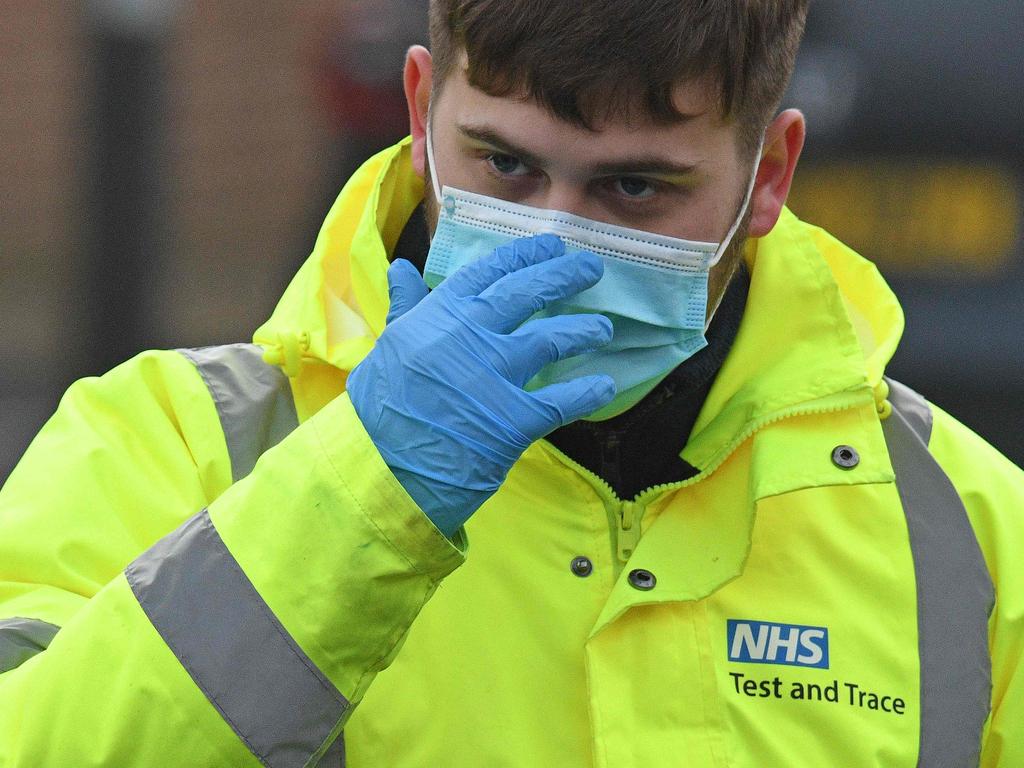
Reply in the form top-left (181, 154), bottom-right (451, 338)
top-left (0, 0), bottom-right (342, 480)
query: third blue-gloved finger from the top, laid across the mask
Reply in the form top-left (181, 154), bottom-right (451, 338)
top-left (508, 314), bottom-right (612, 387)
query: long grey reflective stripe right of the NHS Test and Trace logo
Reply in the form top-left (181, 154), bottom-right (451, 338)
top-left (883, 380), bottom-right (994, 768)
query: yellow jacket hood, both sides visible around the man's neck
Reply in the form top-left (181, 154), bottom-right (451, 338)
top-left (254, 138), bottom-right (903, 467)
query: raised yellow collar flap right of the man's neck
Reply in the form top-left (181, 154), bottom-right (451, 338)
top-left (683, 204), bottom-right (903, 467)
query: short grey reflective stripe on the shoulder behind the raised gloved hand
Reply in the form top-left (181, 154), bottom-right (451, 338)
top-left (178, 344), bottom-right (298, 482)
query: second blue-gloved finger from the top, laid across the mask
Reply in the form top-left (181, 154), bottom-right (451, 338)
top-left (474, 251), bottom-right (604, 333)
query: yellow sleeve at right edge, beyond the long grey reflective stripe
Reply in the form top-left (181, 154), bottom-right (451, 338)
top-left (929, 406), bottom-right (1024, 768)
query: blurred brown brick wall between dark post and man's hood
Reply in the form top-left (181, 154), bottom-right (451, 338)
top-left (157, 0), bottom-right (329, 343)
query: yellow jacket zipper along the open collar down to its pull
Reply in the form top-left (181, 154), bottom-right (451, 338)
top-left (543, 395), bottom-right (873, 565)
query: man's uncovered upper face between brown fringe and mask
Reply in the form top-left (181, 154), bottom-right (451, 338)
top-left (426, 61), bottom-right (753, 301)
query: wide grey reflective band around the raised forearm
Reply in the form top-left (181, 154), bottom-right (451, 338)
top-left (125, 510), bottom-right (348, 768)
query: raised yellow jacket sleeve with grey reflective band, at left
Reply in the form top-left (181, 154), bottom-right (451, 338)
top-left (0, 352), bottom-right (466, 768)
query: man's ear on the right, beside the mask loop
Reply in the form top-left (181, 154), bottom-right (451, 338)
top-left (749, 110), bottom-right (807, 238)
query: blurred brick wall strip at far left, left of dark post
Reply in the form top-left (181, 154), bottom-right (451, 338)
top-left (0, 0), bottom-right (83, 385)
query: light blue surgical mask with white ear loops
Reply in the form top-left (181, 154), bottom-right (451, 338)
top-left (424, 122), bottom-right (764, 421)
